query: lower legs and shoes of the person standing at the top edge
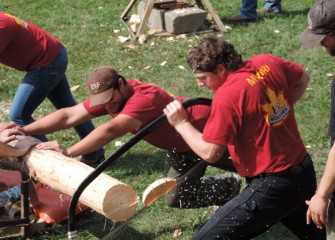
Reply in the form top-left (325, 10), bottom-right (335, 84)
top-left (226, 0), bottom-right (282, 22)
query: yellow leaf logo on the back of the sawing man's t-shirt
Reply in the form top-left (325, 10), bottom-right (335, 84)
top-left (262, 88), bottom-right (290, 126)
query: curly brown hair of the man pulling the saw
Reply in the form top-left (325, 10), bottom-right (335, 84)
top-left (187, 37), bottom-right (243, 72)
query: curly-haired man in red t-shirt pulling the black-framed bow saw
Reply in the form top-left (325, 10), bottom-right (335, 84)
top-left (164, 37), bottom-right (326, 240)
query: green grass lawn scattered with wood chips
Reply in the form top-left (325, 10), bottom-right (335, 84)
top-left (0, 0), bottom-right (335, 240)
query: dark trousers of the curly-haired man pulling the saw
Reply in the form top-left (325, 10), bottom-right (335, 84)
top-left (193, 156), bottom-right (326, 240)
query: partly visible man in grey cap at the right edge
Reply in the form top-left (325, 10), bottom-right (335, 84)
top-left (300, 0), bottom-right (335, 234)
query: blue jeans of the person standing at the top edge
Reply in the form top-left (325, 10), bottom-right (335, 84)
top-left (239, 0), bottom-right (282, 20)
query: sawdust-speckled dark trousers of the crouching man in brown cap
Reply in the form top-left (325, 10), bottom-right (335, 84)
top-left (164, 152), bottom-right (240, 208)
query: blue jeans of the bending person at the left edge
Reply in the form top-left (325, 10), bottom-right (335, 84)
top-left (9, 46), bottom-right (104, 159)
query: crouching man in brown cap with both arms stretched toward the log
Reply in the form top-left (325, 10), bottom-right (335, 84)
top-left (5, 66), bottom-right (241, 208)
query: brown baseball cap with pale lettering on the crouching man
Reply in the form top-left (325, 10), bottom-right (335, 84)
top-left (86, 66), bottom-right (120, 107)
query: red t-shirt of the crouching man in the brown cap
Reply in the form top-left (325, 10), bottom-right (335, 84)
top-left (83, 80), bottom-right (210, 152)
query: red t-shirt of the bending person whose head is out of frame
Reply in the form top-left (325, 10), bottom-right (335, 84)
top-left (0, 12), bottom-right (61, 71)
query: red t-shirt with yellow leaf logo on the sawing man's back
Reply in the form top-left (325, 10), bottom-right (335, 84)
top-left (203, 54), bottom-right (307, 177)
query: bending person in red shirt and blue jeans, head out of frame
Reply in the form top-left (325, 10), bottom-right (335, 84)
top-left (0, 12), bottom-right (104, 163)
